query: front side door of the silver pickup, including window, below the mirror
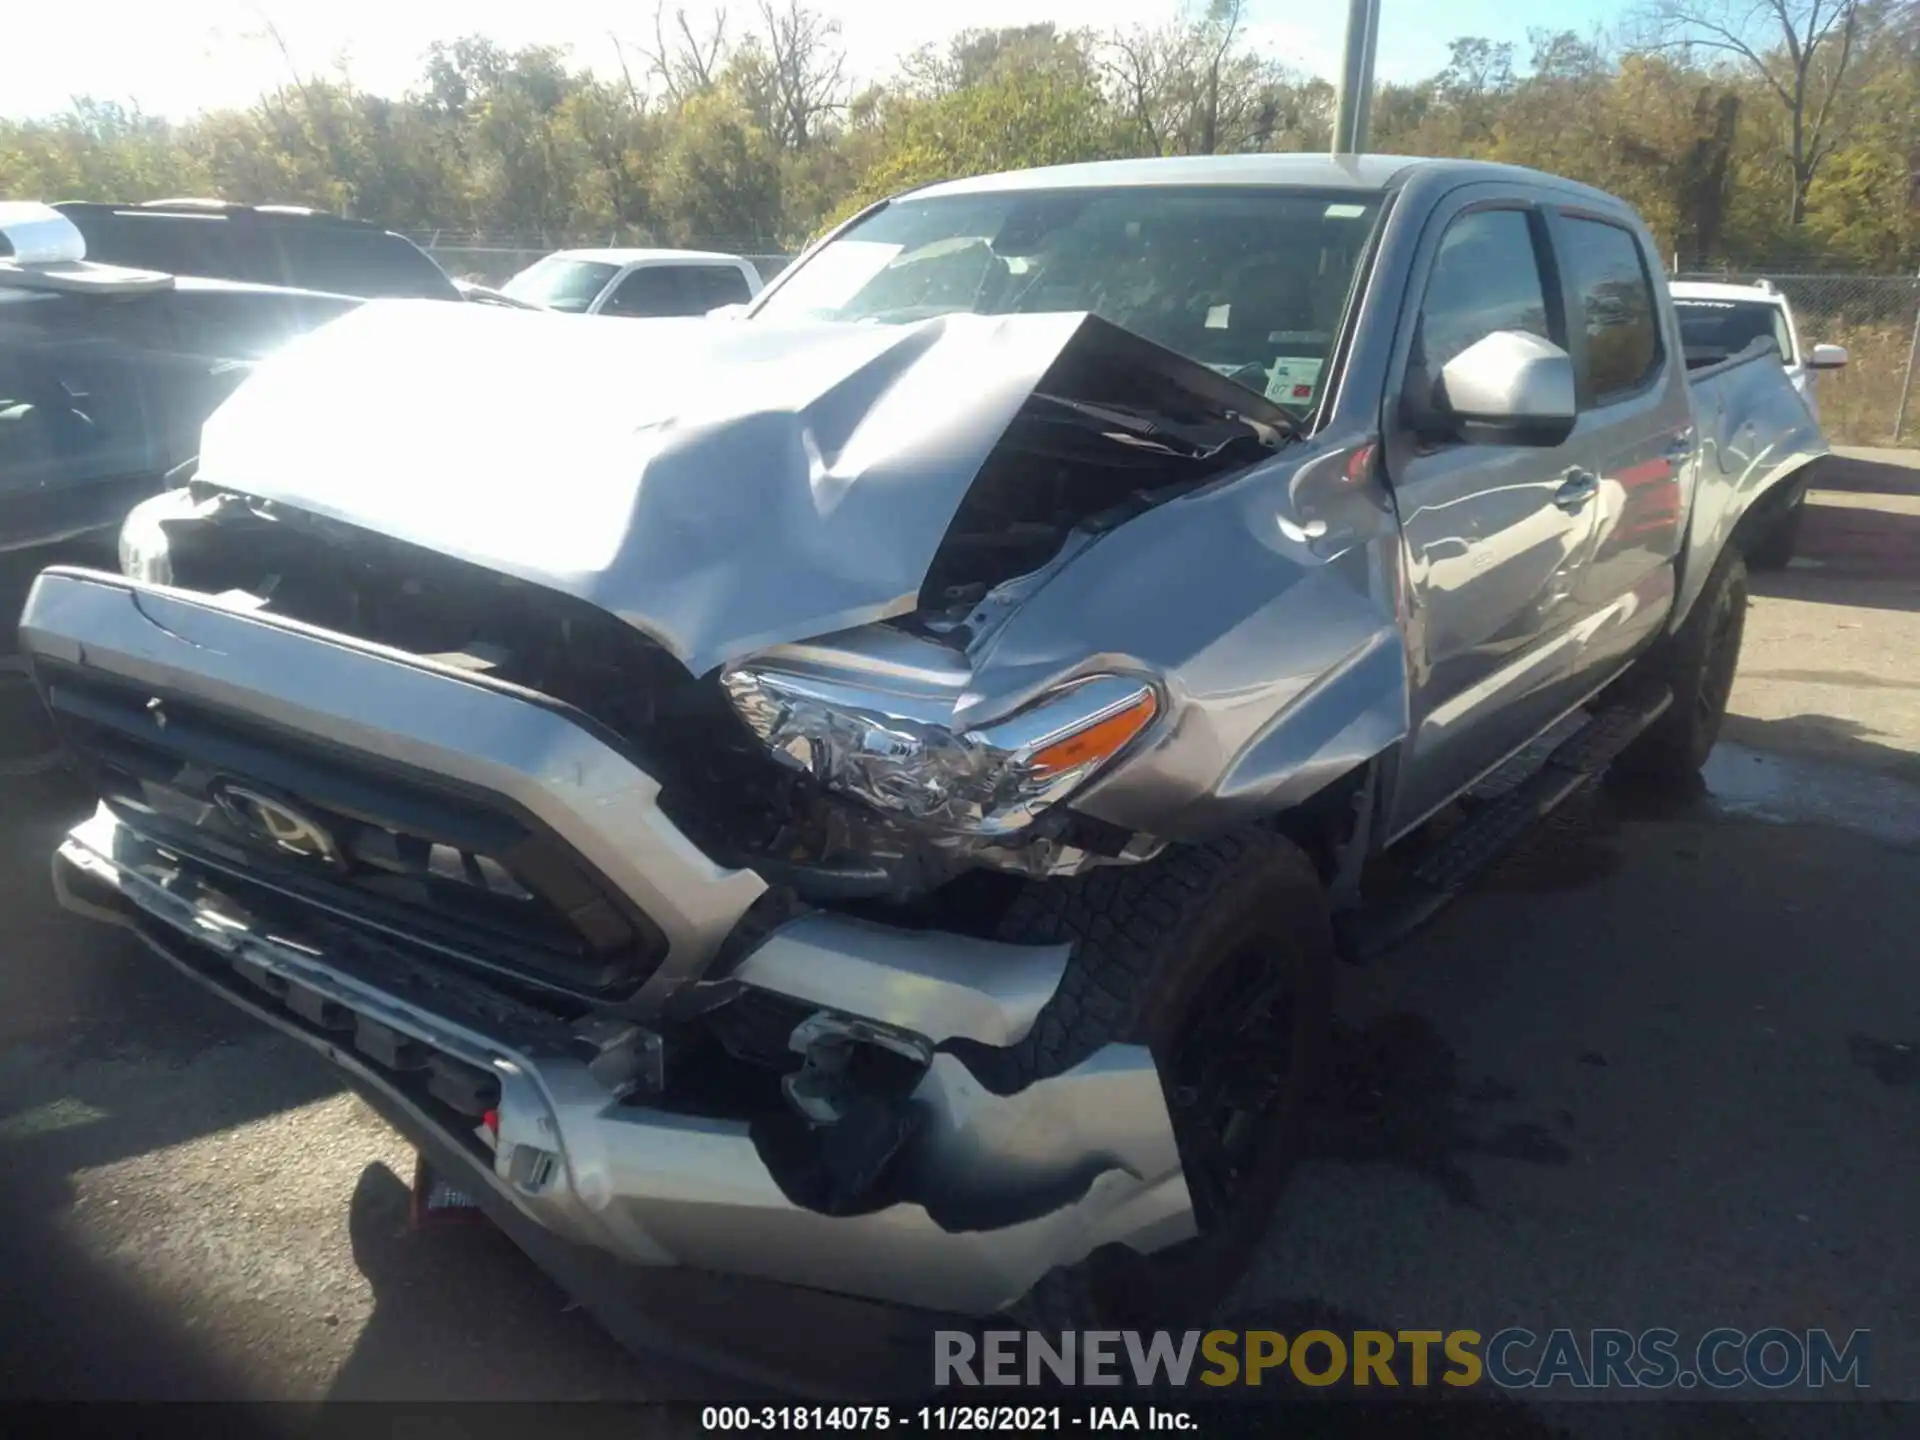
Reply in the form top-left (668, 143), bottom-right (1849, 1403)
top-left (1380, 186), bottom-right (1597, 833)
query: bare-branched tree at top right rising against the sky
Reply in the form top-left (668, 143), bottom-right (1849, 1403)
top-left (1649, 0), bottom-right (1866, 225)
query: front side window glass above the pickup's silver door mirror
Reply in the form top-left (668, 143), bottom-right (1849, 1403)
top-left (1413, 209), bottom-right (1553, 384)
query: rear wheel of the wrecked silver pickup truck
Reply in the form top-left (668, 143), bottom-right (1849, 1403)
top-left (1611, 545), bottom-right (1747, 783)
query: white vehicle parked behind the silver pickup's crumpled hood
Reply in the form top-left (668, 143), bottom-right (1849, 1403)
top-left (501, 250), bottom-right (760, 317)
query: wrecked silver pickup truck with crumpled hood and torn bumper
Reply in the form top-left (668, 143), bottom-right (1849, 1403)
top-left (21, 156), bottom-right (1824, 1327)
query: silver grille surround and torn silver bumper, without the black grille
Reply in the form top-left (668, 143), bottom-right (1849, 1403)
top-left (21, 574), bottom-right (1194, 1315)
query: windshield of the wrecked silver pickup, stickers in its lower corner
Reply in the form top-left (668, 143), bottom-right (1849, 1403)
top-left (756, 186), bottom-right (1380, 417)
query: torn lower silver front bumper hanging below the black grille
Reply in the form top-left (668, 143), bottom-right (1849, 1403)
top-left (54, 810), bottom-right (1192, 1313)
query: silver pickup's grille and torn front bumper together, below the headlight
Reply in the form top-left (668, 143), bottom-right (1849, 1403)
top-left (25, 570), bottom-right (1192, 1313)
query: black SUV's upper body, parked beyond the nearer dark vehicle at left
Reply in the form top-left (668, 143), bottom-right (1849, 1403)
top-left (56, 200), bottom-right (461, 300)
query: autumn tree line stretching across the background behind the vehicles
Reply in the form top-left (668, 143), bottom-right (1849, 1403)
top-left (0, 0), bottom-right (1920, 273)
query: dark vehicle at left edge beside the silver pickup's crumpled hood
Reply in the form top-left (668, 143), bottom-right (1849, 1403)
top-left (0, 202), bottom-right (359, 560)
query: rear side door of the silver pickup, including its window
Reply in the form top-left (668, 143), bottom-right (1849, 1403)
top-left (1549, 207), bottom-right (1695, 689)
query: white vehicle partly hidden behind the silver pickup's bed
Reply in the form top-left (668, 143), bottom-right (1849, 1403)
top-left (1670, 280), bottom-right (1847, 570)
